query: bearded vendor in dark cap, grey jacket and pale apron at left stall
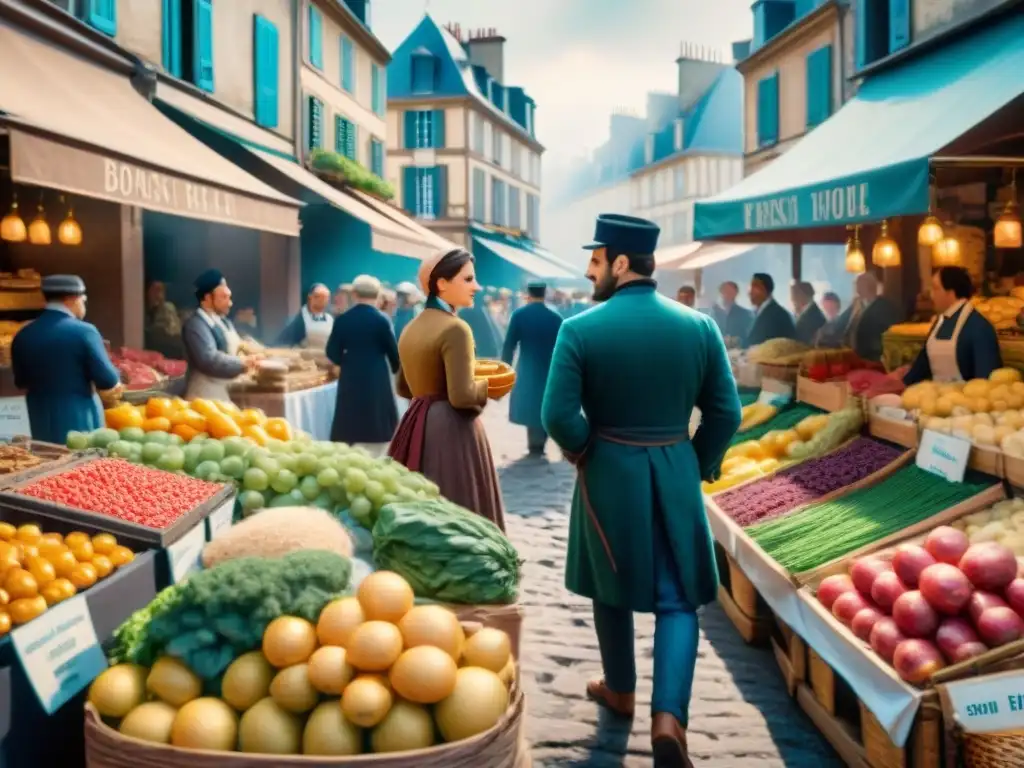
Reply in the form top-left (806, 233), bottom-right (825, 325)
top-left (181, 269), bottom-right (255, 401)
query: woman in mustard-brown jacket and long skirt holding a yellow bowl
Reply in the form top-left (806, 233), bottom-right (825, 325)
top-left (388, 248), bottom-right (505, 530)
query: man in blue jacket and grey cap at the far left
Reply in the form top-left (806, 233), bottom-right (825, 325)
top-left (10, 274), bottom-right (123, 445)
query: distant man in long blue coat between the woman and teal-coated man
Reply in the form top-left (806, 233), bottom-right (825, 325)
top-left (502, 282), bottom-right (562, 456)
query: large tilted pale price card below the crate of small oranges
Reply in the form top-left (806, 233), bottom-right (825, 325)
top-left (10, 595), bottom-right (106, 715)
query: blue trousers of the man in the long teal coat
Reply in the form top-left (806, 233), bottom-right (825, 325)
top-left (594, 512), bottom-right (699, 727)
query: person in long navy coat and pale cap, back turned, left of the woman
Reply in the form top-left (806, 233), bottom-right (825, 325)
top-left (327, 274), bottom-right (398, 456)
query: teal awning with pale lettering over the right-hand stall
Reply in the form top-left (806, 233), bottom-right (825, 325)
top-left (693, 13), bottom-right (1024, 240)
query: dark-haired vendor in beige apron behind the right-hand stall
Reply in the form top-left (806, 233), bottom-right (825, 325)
top-left (903, 266), bottom-right (1002, 385)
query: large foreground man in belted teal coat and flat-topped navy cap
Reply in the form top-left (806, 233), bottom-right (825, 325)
top-left (541, 214), bottom-right (740, 768)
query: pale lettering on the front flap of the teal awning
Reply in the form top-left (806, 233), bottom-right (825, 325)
top-left (743, 181), bottom-right (871, 231)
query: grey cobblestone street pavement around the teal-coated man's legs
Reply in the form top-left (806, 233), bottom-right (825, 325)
top-left (484, 400), bottom-right (843, 768)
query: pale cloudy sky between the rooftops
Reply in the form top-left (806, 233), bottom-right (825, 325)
top-left (372, 0), bottom-right (753, 174)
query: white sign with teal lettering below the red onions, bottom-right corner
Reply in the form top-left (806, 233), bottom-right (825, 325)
top-left (946, 670), bottom-right (1024, 733)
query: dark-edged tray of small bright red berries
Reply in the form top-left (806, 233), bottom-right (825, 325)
top-left (0, 456), bottom-right (234, 548)
